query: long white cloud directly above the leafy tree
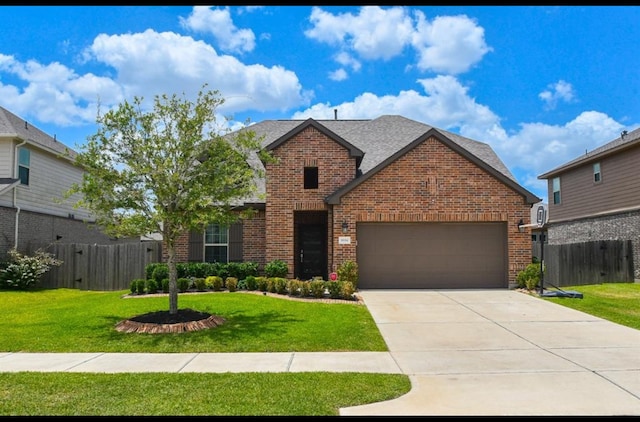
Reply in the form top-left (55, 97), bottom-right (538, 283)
top-left (89, 30), bottom-right (307, 111)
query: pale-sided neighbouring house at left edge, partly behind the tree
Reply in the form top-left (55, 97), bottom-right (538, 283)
top-left (0, 107), bottom-right (136, 260)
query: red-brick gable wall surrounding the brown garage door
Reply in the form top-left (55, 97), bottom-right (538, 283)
top-left (332, 138), bottom-right (531, 287)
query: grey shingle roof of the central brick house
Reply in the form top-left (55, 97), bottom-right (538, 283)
top-left (242, 115), bottom-right (540, 203)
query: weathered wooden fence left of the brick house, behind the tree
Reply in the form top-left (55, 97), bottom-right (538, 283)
top-left (29, 241), bottom-right (162, 291)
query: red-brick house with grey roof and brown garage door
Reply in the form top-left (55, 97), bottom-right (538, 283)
top-left (177, 115), bottom-right (540, 288)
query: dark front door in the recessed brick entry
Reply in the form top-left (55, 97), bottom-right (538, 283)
top-left (297, 224), bottom-right (327, 280)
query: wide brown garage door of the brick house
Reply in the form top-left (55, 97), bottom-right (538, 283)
top-left (356, 223), bottom-right (508, 289)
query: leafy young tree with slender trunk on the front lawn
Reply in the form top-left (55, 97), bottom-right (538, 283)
top-left (66, 84), bottom-right (271, 314)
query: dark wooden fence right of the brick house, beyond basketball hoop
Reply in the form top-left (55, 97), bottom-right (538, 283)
top-left (544, 240), bottom-right (634, 287)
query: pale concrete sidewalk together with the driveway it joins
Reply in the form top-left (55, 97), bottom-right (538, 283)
top-left (0, 290), bottom-right (640, 416)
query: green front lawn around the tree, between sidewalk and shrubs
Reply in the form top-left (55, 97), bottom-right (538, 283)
top-left (0, 289), bottom-right (387, 353)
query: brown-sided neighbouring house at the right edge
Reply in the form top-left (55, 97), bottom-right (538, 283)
top-left (538, 129), bottom-right (640, 279)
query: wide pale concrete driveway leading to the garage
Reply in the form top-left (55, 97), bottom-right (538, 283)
top-left (340, 290), bottom-right (640, 416)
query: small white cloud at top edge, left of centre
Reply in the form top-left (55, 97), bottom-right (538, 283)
top-left (180, 6), bottom-right (256, 53)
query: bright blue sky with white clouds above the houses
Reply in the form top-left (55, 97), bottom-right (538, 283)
top-left (0, 6), bottom-right (640, 202)
